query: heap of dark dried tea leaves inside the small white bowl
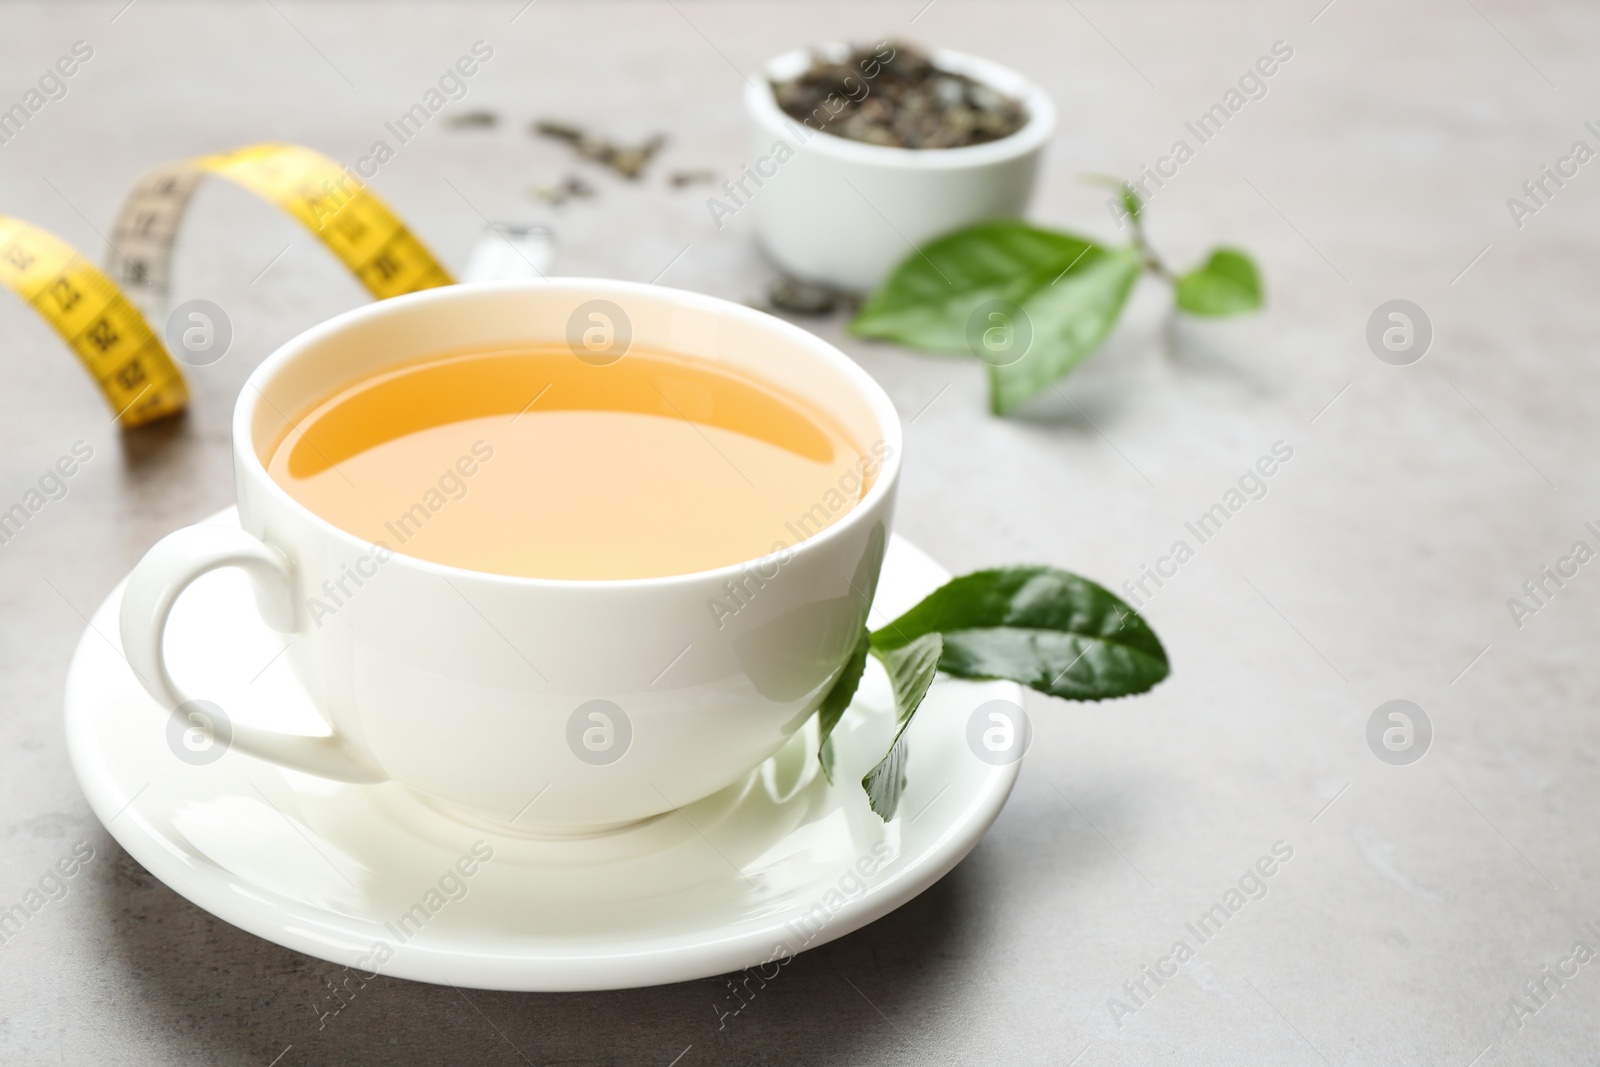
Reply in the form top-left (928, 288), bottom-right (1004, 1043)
top-left (771, 42), bottom-right (1027, 149)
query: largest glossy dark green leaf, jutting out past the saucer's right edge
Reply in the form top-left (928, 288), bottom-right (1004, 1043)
top-left (872, 566), bottom-right (1168, 701)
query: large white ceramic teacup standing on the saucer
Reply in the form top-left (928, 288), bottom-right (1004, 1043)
top-left (122, 278), bottom-right (901, 833)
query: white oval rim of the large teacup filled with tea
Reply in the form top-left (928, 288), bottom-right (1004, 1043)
top-left (232, 278), bottom-right (904, 589)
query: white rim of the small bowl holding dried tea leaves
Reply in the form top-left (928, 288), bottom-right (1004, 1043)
top-left (744, 42), bottom-right (1056, 171)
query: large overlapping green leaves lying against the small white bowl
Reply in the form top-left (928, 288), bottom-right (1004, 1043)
top-left (850, 221), bottom-right (1142, 414)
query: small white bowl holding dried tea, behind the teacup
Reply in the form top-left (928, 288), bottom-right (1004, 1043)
top-left (742, 43), bottom-right (1056, 291)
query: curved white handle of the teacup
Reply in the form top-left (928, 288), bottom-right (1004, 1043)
top-left (120, 525), bottom-right (387, 782)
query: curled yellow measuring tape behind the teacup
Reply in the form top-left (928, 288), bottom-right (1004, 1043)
top-left (0, 144), bottom-right (453, 426)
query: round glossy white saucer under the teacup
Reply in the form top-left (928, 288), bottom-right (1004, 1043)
top-left (66, 509), bottom-right (1022, 992)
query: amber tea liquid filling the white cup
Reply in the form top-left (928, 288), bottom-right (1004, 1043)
top-left (266, 346), bottom-right (883, 579)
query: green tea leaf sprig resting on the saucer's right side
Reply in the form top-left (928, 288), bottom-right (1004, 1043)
top-left (818, 566), bottom-right (1170, 821)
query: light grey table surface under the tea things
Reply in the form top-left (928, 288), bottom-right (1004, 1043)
top-left (0, 0), bottom-right (1600, 1067)
